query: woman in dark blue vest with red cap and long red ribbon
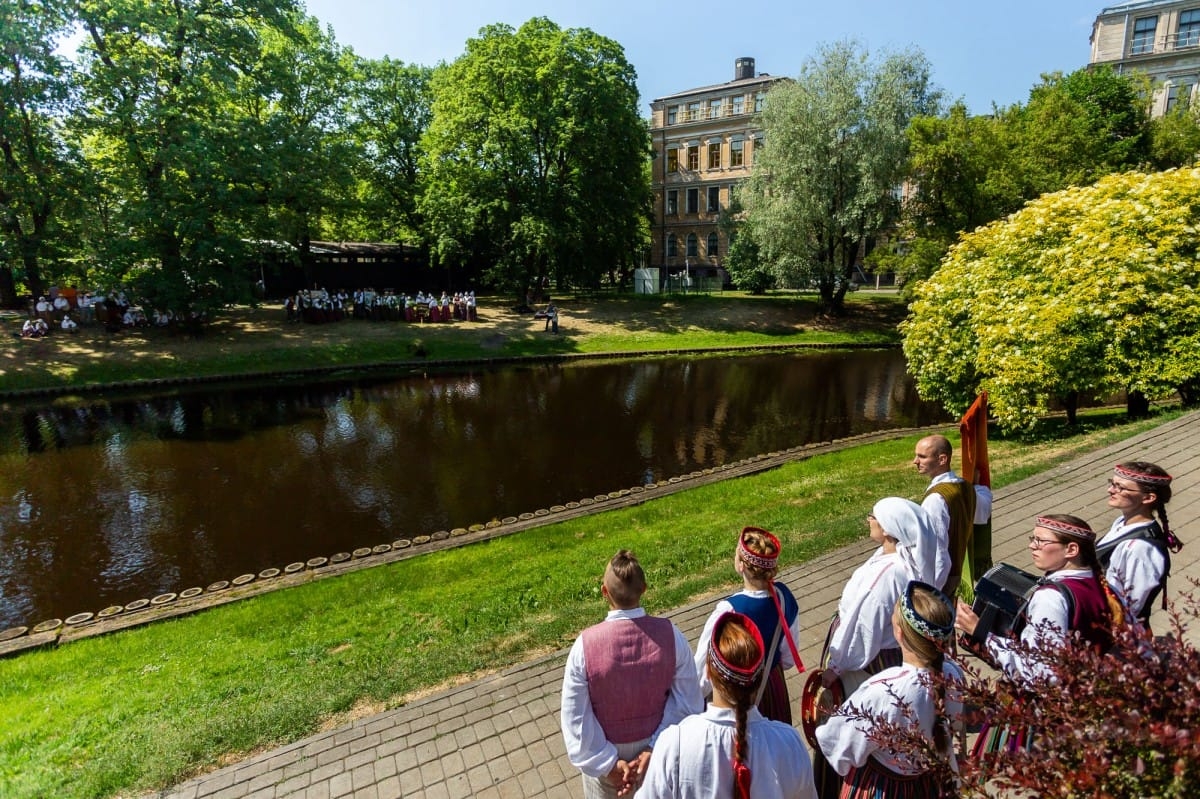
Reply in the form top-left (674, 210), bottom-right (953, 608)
top-left (696, 527), bottom-right (803, 723)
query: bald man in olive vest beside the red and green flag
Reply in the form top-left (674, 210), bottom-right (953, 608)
top-left (912, 435), bottom-right (976, 596)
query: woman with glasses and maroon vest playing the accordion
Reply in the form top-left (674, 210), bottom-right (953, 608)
top-left (955, 513), bottom-right (1118, 684)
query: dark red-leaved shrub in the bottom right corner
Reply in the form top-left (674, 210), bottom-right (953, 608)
top-left (835, 581), bottom-right (1200, 799)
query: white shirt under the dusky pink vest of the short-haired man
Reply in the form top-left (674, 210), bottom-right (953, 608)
top-left (560, 607), bottom-right (704, 777)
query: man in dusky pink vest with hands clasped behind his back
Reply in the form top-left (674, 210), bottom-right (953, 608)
top-left (560, 549), bottom-right (704, 799)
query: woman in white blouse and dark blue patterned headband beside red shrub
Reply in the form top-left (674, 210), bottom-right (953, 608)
top-left (816, 581), bottom-right (962, 799)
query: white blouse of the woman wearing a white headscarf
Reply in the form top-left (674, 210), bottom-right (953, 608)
top-left (828, 547), bottom-right (908, 673)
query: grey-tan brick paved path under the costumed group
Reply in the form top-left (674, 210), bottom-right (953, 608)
top-left (158, 413), bottom-right (1200, 799)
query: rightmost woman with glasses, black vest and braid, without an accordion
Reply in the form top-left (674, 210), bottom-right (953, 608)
top-left (1096, 461), bottom-right (1183, 627)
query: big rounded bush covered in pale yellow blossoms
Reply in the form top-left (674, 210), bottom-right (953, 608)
top-left (901, 168), bottom-right (1200, 428)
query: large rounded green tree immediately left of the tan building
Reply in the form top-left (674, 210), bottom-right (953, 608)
top-left (420, 18), bottom-right (650, 298)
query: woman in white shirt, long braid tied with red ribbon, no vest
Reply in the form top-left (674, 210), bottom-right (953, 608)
top-left (637, 613), bottom-right (817, 799)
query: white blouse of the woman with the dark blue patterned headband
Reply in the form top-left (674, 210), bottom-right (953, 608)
top-left (817, 661), bottom-right (962, 776)
